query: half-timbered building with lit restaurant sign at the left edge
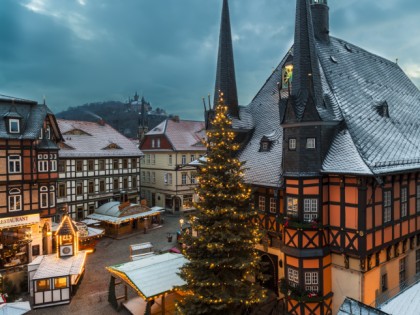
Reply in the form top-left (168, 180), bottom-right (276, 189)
top-left (0, 96), bottom-right (62, 276)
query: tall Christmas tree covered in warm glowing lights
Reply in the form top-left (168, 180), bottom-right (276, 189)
top-left (177, 95), bottom-right (265, 315)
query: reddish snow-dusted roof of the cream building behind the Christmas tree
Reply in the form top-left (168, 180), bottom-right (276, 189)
top-left (144, 119), bottom-right (206, 152)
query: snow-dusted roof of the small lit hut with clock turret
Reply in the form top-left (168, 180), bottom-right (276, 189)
top-left (28, 251), bottom-right (87, 280)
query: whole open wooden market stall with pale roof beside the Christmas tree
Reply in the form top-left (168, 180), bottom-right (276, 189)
top-left (106, 253), bottom-right (188, 315)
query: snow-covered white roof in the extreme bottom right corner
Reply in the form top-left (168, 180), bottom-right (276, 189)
top-left (379, 282), bottom-right (420, 315)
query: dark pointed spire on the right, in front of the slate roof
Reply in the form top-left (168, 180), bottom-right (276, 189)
top-left (292, 0), bottom-right (320, 120)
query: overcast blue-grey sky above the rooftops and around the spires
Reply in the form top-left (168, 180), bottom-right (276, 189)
top-left (0, 0), bottom-right (420, 119)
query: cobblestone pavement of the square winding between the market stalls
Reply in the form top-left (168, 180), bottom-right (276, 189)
top-left (28, 214), bottom-right (185, 315)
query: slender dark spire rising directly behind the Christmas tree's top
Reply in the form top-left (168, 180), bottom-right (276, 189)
top-left (214, 0), bottom-right (239, 117)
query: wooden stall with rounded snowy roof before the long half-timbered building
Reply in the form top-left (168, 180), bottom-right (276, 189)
top-left (87, 201), bottom-right (163, 238)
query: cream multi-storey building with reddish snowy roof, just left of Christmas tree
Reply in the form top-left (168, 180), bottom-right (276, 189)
top-left (140, 117), bottom-right (206, 212)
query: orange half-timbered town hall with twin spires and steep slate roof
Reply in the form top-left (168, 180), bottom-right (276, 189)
top-left (210, 0), bottom-right (420, 314)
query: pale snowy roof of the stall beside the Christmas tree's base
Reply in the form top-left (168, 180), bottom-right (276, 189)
top-left (107, 253), bottom-right (188, 298)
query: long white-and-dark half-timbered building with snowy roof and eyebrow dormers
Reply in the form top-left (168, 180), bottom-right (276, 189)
top-left (57, 119), bottom-right (142, 221)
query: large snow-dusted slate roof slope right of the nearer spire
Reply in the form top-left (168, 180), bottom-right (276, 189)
top-left (317, 37), bottom-right (420, 174)
